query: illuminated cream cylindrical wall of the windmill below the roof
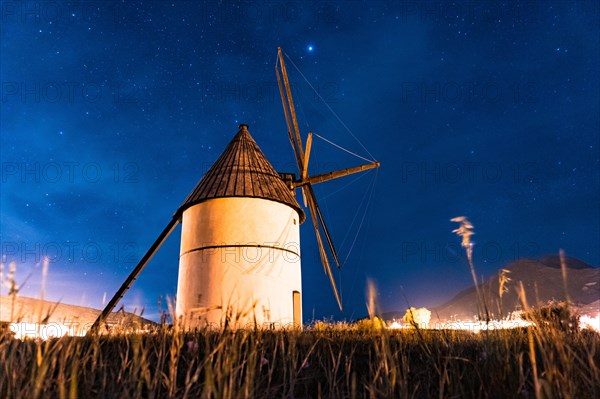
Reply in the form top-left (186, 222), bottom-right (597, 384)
top-left (176, 197), bottom-right (302, 328)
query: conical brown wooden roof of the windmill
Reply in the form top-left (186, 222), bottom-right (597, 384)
top-left (177, 125), bottom-right (305, 222)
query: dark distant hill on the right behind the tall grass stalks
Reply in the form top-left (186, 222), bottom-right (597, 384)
top-left (431, 256), bottom-right (600, 321)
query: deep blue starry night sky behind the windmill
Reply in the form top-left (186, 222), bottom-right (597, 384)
top-left (0, 1), bottom-right (600, 321)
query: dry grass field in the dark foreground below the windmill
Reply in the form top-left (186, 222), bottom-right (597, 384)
top-left (0, 323), bottom-right (600, 398)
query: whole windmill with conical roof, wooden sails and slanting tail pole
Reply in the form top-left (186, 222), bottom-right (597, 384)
top-left (90, 49), bottom-right (379, 332)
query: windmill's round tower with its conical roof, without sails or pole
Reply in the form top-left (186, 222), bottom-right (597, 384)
top-left (176, 125), bottom-right (304, 328)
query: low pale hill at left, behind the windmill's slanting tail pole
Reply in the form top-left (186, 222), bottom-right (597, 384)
top-left (0, 295), bottom-right (156, 327)
